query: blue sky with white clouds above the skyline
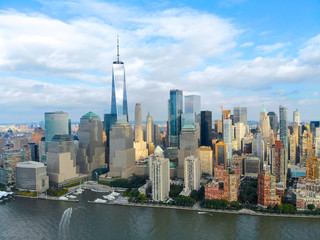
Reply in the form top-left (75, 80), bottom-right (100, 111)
top-left (0, 0), bottom-right (320, 123)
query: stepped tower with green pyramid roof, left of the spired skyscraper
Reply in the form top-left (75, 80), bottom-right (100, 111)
top-left (77, 112), bottom-right (106, 174)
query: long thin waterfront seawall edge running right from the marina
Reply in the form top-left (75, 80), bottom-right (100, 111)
top-left (88, 201), bottom-right (320, 219)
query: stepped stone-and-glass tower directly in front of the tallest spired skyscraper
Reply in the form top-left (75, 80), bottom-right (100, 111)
top-left (108, 119), bottom-right (135, 176)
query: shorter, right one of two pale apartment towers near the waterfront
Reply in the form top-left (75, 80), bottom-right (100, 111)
top-left (184, 156), bottom-right (201, 191)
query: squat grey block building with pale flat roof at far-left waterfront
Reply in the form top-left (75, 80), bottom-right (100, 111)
top-left (15, 161), bottom-right (49, 192)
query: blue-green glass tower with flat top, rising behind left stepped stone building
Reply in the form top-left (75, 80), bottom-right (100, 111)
top-left (44, 111), bottom-right (69, 148)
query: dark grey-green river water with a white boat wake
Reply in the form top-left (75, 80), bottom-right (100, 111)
top-left (0, 190), bottom-right (320, 240)
